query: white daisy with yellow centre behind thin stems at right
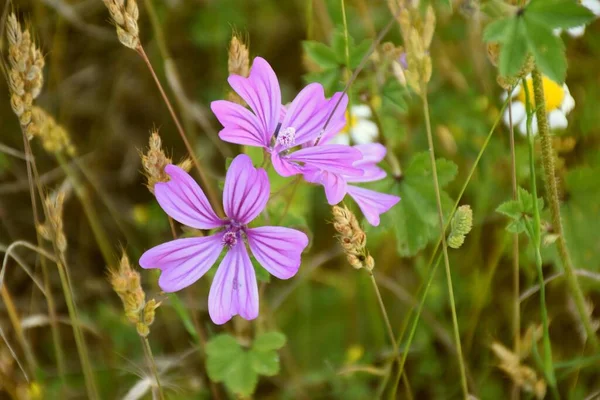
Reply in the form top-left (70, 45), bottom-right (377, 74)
top-left (502, 76), bottom-right (575, 135)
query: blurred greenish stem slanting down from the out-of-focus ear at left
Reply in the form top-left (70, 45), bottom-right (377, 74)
top-left (55, 152), bottom-right (114, 265)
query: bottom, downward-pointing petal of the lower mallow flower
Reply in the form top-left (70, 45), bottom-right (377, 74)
top-left (208, 243), bottom-right (258, 325)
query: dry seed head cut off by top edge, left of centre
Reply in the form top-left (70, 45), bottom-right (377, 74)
top-left (103, 0), bottom-right (140, 50)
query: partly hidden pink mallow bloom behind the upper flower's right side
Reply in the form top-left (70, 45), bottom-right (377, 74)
top-left (304, 140), bottom-right (400, 226)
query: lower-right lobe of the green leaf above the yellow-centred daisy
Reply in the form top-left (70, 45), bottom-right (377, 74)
top-left (524, 14), bottom-right (567, 83)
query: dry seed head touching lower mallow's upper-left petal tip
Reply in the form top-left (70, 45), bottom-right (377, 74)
top-left (140, 130), bottom-right (193, 193)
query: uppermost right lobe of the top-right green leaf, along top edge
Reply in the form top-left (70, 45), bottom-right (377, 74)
top-left (524, 0), bottom-right (595, 29)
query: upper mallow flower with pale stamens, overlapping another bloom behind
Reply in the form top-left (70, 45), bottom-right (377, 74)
top-left (210, 57), bottom-right (361, 176)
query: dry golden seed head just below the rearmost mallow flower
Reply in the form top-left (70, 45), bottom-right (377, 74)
top-left (332, 206), bottom-right (375, 271)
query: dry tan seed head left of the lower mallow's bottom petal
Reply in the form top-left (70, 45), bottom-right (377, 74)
top-left (109, 252), bottom-right (160, 337)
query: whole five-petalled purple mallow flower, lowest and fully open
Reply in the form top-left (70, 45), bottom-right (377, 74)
top-left (140, 155), bottom-right (308, 324)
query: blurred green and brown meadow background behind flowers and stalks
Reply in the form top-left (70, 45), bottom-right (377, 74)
top-left (0, 0), bottom-right (600, 399)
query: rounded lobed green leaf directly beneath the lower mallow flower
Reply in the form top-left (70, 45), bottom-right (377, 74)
top-left (206, 332), bottom-right (286, 396)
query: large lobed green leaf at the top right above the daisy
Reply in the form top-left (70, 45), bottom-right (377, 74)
top-left (483, 0), bottom-right (594, 83)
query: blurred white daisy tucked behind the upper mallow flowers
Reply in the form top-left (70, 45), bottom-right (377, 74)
top-left (329, 104), bottom-right (379, 145)
